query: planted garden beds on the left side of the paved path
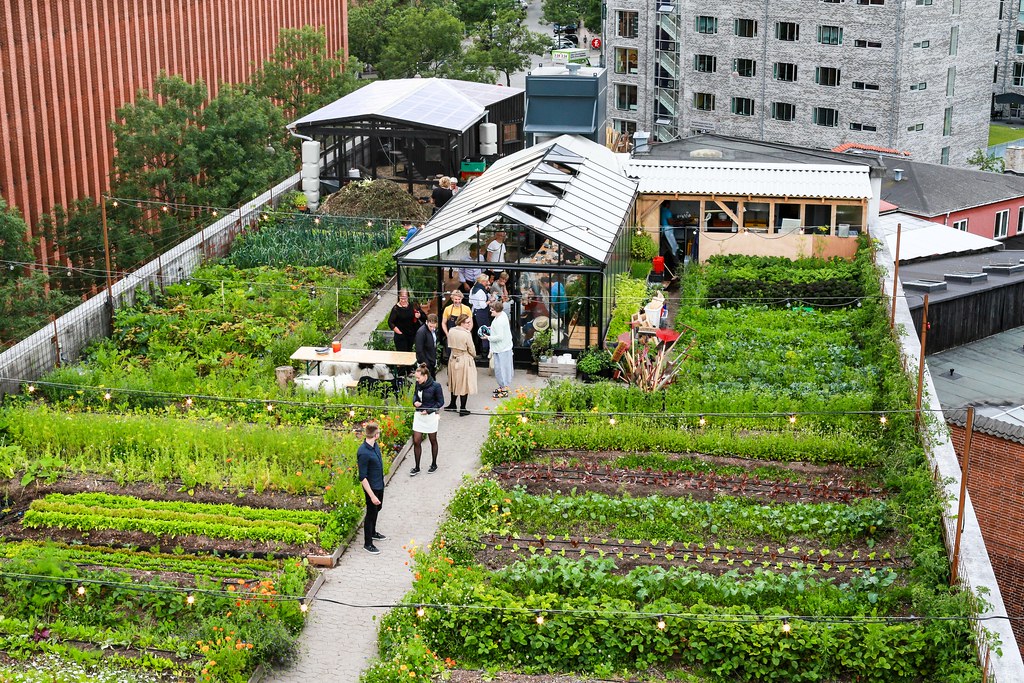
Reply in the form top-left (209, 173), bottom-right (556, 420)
top-left (0, 206), bottom-right (409, 682)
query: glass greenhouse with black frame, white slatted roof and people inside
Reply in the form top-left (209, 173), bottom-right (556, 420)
top-left (396, 135), bottom-right (637, 360)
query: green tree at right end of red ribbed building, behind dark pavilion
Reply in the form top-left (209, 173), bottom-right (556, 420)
top-left (250, 26), bottom-right (361, 121)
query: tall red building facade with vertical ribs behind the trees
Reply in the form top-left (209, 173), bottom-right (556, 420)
top-left (0, 0), bottom-right (348, 236)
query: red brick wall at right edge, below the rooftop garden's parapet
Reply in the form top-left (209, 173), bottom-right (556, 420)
top-left (948, 411), bottom-right (1024, 645)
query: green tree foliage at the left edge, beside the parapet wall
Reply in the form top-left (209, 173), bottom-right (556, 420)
top-left (0, 199), bottom-right (75, 346)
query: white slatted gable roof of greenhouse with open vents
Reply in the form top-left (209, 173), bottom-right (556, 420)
top-left (397, 135), bottom-right (636, 263)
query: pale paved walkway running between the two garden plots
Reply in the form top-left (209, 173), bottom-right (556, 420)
top-left (263, 295), bottom-right (545, 683)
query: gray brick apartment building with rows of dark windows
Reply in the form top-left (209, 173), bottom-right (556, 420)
top-left (604, 0), bottom-right (995, 166)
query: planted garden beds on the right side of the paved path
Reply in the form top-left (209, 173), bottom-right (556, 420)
top-left (364, 240), bottom-right (982, 683)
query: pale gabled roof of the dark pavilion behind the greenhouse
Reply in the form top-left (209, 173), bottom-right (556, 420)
top-left (292, 78), bottom-right (522, 133)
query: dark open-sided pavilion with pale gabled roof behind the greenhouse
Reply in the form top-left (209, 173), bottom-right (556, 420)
top-left (289, 78), bottom-right (525, 191)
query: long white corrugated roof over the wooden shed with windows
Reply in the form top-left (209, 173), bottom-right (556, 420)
top-left (626, 159), bottom-right (871, 200)
